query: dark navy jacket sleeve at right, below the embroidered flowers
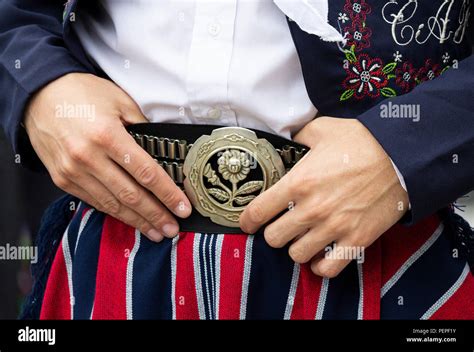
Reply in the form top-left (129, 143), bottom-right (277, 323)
top-left (358, 46), bottom-right (474, 224)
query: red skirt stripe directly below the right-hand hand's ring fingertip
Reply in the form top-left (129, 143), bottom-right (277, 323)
top-left (290, 263), bottom-right (322, 320)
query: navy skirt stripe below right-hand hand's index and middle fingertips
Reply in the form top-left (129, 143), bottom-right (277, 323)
top-left (246, 235), bottom-right (294, 319)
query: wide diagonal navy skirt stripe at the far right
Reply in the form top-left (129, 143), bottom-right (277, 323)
top-left (381, 229), bottom-right (466, 319)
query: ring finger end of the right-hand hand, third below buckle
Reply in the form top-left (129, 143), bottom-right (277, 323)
top-left (288, 226), bottom-right (338, 264)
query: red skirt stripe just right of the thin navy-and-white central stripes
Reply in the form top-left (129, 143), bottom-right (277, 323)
top-left (219, 235), bottom-right (248, 319)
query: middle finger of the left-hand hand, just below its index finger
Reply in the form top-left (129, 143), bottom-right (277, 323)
top-left (89, 159), bottom-right (179, 237)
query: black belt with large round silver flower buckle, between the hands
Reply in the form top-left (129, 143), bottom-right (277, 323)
top-left (127, 123), bottom-right (308, 233)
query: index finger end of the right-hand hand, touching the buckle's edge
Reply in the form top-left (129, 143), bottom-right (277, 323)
top-left (239, 175), bottom-right (293, 233)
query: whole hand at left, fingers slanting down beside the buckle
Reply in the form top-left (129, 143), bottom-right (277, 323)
top-left (24, 73), bottom-right (191, 242)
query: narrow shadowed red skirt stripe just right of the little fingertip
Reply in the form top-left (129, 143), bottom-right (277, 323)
top-left (362, 240), bottom-right (382, 320)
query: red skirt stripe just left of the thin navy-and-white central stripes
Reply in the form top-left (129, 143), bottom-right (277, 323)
top-left (175, 232), bottom-right (199, 319)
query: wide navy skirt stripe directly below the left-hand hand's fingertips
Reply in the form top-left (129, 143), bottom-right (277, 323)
top-left (131, 235), bottom-right (173, 319)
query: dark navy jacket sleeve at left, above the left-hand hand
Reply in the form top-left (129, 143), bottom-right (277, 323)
top-left (0, 0), bottom-right (89, 169)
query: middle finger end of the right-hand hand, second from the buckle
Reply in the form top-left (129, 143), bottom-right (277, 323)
top-left (264, 204), bottom-right (310, 248)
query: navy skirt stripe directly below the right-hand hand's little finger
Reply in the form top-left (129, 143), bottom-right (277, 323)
top-left (322, 260), bottom-right (360, 320)
